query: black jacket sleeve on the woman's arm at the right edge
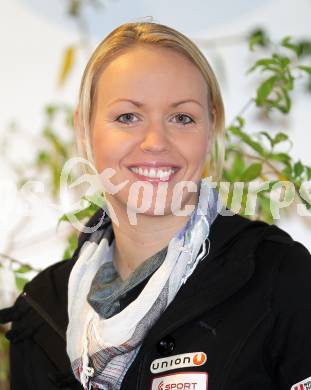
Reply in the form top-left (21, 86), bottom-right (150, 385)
top-left (269, 241), bottom-right (311, 390)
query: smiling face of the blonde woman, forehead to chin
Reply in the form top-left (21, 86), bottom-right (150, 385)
top-left (91, 45), bottom-right (216, 219)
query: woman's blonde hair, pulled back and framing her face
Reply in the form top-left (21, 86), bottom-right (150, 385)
top-left (76, 21), bottom-right (225, 181)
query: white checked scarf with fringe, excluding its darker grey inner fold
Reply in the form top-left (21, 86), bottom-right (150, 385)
top-left (67, 179), bottom-right (221, 390)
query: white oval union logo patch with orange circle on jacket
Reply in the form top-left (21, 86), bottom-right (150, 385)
top-left (150, 352), bottom-right (207, 374)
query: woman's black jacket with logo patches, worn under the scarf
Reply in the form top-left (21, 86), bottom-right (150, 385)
top-left (0, 211), bottom-right (311, 390)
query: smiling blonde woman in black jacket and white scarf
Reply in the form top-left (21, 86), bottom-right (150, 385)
top-left (1, 22), bottom-right (311, 390)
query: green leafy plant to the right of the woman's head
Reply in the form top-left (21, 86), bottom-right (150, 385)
top-left (223, 30), bottom-right (311, 222)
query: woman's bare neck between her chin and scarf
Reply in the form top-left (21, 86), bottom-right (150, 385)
top-left (111, 194), bottom-right (199, 280)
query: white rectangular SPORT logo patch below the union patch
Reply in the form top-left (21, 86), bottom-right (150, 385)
top-left (151, 371), bottom-right (208, 390)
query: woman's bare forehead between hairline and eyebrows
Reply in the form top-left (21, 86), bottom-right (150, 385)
top-left (97, 45), bottom-right (207, 103)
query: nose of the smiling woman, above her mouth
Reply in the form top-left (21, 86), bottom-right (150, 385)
top-left (140, 125), bottom-right (169, 152)
